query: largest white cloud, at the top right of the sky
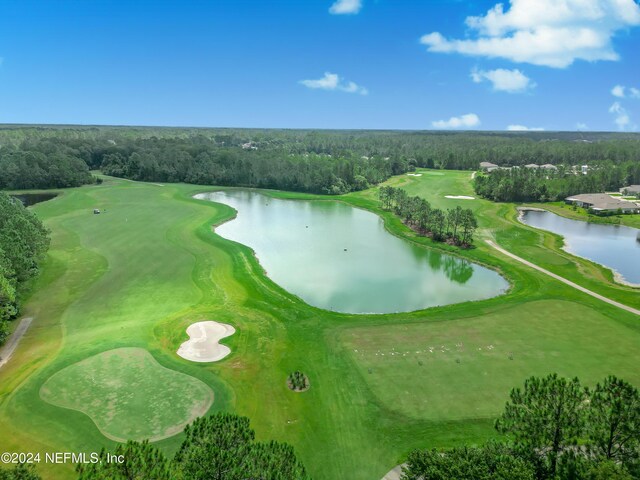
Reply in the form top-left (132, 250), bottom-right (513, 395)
top-left (420, 0), bottom-right (640, 68)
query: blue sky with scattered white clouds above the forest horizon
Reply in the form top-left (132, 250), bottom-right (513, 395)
top-left (0, 0), bottom-right (640, 131)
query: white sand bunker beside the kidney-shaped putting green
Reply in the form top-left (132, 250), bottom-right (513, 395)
top-left (178, 321), bottom-right (236, 362)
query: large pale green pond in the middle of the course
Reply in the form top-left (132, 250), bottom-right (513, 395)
top-left (196, 190), bottom-right (508, 313)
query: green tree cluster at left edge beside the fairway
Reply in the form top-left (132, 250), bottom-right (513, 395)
top-left (0, 192), bottom-right (49, 345)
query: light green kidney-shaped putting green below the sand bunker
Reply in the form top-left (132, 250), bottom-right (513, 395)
top-left (40, 348), bottom-right (213, 442)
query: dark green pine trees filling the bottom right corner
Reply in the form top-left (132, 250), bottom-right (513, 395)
top-left (402, 374), bottom-right (640, 480)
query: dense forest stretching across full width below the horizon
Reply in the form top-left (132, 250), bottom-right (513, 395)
top-left (0, 126), bottom-right (640, 194)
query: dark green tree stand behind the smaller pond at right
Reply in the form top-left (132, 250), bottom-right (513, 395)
top-left (474, 161), bottom-right (640, 202)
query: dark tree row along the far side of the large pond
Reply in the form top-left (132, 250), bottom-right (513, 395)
top-left (100, 148), bottom-right (400, 195)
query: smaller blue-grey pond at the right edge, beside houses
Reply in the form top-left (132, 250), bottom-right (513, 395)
top-left (521, 211), bottom-right (640, 284)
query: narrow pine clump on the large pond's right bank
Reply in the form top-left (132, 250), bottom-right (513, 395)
top-left (378, 186), bottom-right (478, 246)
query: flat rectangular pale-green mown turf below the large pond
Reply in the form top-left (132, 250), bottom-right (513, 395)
top-left (342, 300), bottom-right (640, 421)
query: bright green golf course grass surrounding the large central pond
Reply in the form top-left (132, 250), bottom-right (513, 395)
top-left (0, 171), bottom-right (640, 480)
